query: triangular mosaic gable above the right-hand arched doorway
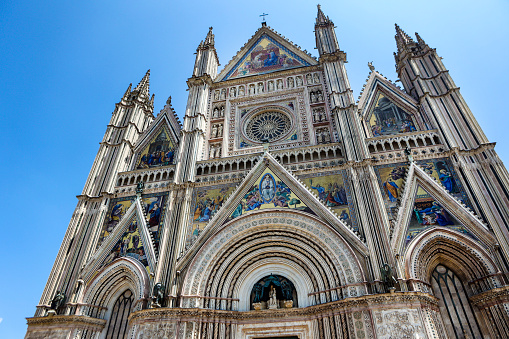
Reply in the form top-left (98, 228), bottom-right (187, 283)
top-left (391, 163), bottom-right (495, 253)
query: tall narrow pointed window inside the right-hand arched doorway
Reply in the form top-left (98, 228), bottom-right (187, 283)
top-left (431, 265), bottom-right (482, 338)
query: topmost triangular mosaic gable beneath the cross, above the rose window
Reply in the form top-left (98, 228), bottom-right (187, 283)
top-left (217, 27), bottom-right (317, 81)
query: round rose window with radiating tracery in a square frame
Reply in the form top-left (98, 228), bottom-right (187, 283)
top-left (246, 111), bottom-right (292, 142)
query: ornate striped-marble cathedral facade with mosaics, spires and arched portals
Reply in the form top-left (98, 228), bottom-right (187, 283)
top-left (25, 7), bottom-right (509, 339)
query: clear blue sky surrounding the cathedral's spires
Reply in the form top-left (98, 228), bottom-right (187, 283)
top-left (0, 0), bottom-right (509, 338)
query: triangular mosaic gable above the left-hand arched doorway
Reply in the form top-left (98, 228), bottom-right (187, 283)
top-left (82, 198), bottom-right (157, 281)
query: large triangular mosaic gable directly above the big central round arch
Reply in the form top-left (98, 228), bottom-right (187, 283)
top-left (188, 152), bottom-right (368, 254)
